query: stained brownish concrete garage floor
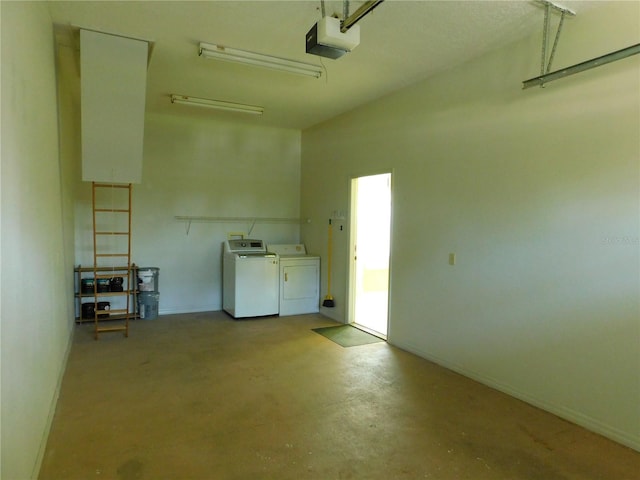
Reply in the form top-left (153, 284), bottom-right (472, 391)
top-left (40, 312), bottom-right (640, 480)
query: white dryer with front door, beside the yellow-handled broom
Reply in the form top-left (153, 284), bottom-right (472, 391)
top-left (269, 244), bottom-right (320, 316)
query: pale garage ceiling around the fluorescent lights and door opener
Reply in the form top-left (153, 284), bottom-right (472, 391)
top-left (50, 0), bottom-right (600, 129)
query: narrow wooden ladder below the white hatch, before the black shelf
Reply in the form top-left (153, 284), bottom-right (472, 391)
top-left (92, 182), bottom-right (136, 340)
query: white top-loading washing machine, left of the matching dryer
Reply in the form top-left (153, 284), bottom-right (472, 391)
top-left (222, 239), bottom-right (280, 318)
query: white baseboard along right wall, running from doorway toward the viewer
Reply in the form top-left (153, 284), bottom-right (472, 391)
top-left (392, 342), bottom-right (640, 452)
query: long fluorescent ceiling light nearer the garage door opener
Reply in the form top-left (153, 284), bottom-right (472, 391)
top-left (200, 43), bottom-right (322, 78)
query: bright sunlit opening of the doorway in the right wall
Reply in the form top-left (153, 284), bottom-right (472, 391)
top-left (349, 173), bottom-right (391, 338)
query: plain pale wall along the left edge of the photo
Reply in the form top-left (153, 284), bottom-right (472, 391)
top-left (0, 2), bottom-right (73, 480)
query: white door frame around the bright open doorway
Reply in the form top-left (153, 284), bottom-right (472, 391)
top-left (346, 168), bottom-right (395, 340)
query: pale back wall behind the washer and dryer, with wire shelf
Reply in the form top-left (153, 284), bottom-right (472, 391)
top-left (76, 112), bottom-right (301, 314)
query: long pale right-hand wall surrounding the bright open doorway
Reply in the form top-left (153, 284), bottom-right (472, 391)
top-left (301, 2), bottom-right (640, 449)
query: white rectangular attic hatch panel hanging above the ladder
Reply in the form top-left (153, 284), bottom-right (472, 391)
top-left (80, 29), bottom-right (149, 183)
